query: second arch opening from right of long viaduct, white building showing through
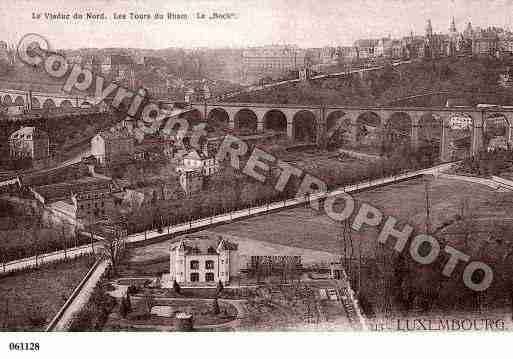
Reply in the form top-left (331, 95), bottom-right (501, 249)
top-left (443, 113), bottom-right (474, 160)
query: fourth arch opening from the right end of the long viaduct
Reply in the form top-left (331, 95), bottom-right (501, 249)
top-left (383, 112), bottom-right (413, 152)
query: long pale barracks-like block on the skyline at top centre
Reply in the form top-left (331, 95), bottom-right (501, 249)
top-left (242, 46), bottom-right (306, 78)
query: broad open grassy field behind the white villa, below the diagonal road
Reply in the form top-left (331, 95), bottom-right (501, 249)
top-left (202, 179), bottom-right (498, 257)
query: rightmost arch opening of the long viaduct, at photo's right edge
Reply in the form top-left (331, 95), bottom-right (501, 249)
top-left (481, 113), bottom-right (511, 151)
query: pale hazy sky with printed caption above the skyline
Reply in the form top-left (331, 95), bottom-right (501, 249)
top-left (0, 0), bottom-right (513, 49)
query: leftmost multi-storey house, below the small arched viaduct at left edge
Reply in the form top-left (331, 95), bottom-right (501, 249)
top-left (9, 127), bottom-right (50, 160)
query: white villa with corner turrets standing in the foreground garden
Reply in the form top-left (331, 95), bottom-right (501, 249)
top-left (169, 236), bottom-right (239, 285)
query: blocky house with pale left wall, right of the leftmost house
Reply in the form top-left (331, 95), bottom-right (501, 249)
top-left (91, 128), bottom-right (135, 166)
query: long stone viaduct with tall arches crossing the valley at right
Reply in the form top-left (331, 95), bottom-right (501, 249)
top-left (191, 103), bottom-right (513, 160)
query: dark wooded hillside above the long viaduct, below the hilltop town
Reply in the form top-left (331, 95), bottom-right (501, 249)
top-left (229, 58), bottom-right (513, 106)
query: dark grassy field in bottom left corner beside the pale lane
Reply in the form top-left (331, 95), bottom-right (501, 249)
top-left (0, 257), bottom-right (94, 331)
